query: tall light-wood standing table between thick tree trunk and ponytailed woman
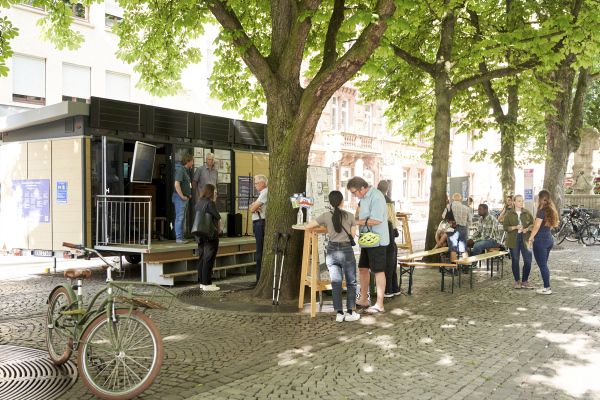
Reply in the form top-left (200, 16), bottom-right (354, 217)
top-left (292, 225), bottom-right (345, 317)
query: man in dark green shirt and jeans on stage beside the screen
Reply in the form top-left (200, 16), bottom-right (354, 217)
top-left (171, 154), bottom-right (194, 244)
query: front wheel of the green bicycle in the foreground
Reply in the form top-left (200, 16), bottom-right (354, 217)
top-left (77, 309), bottom-right (163, 400)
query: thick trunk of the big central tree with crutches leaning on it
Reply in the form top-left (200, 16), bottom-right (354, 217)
top-left (255, 96), bottom-right (322, 299)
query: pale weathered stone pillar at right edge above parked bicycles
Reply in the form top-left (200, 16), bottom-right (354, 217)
top-left (572, 128), bottom-right (600, 194)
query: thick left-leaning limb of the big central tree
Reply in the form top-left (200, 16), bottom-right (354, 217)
top-left (209, 0), bottom-right (275, 93)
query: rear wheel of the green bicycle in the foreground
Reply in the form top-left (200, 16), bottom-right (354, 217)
top-left (46, 287), bottom-right (75, 365)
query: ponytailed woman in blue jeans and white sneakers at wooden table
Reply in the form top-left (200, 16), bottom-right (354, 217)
top-left (306, 190), bottom-right (360, 322)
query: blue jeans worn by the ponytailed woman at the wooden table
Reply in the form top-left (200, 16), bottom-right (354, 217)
top-left (326, 242), bottom-right (356, 311)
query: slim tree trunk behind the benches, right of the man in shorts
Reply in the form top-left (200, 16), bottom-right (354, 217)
top-left (425, 85), bottom-right (454, 253)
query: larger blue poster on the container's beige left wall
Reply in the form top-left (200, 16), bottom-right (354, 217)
top-left (12, 179), bottom-right (50, 223)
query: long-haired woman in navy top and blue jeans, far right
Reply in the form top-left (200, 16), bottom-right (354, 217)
top-left (529, 189), bottom-right (558, 294)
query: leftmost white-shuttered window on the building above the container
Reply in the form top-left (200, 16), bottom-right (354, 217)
top-left (12, 54), bottom-right (46, 105)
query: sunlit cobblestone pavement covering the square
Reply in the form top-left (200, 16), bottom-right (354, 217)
top-left (0, 239), bottom-right (600, 400)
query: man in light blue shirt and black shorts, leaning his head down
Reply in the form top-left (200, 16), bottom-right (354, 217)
top-left (346, 176), bottom-right (390, 314)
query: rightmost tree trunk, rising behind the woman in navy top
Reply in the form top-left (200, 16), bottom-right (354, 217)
top-left (544, 68), bottom-right (576, 209)
